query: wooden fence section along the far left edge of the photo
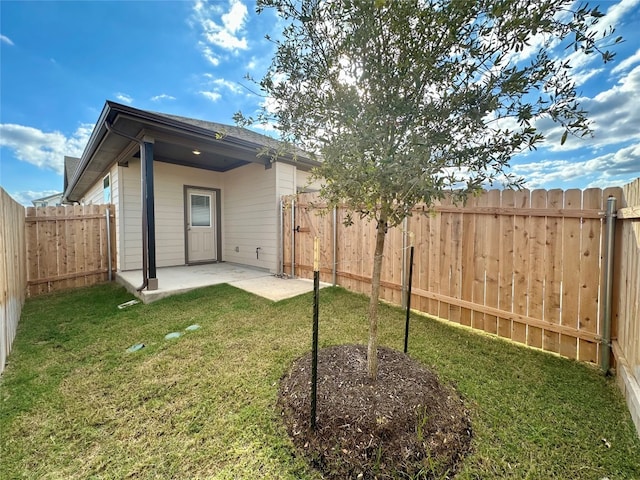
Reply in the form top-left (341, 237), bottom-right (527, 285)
top-left (0, 188), bottom-right (27, 373)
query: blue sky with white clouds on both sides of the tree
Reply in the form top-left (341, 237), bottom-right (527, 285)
top-left (0, 0), bottom-right (640, 204)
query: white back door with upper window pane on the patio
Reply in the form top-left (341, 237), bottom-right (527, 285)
top-left (186, 188), bottom-right (217, 263)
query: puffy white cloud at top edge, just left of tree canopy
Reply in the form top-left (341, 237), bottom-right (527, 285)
top-left (193, 0), bottom-right (249, 66)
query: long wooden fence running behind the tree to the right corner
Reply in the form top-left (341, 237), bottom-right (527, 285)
top-left (283, 188), bottom-right (622, 362)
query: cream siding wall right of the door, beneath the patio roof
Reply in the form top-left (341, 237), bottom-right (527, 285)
top-left (222, 164), bottom-right (279, 273)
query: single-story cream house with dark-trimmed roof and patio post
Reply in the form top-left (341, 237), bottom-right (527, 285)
top-left (63, 101), bottom-right (318, 290)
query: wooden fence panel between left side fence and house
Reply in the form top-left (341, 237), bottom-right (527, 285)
top-left (26, 205), bottom-right (116, 295)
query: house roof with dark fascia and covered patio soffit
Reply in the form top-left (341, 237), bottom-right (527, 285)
top-left (64, 101), bottom-right (319, 202)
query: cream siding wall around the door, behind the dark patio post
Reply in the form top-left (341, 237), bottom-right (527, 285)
top-left (120, 159), bottom-right (225, 270)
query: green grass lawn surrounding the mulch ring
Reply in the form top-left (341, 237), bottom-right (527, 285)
top-left (0, 285), bottom-right (640, 480)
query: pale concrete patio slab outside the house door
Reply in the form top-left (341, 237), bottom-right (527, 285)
top-left (116, 263), bottom-right (329, 303)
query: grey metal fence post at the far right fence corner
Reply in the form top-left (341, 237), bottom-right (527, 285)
top-left (600, 196), bottom-right (617, 374)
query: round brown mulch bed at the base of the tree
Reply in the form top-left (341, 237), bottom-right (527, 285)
top-left (278, 345), bottom-right (472, 479)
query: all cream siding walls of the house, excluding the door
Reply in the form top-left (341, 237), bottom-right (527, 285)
top-left (82, 159), bottom-right (308, 273)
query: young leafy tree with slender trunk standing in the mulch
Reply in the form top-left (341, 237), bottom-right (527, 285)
top-left (236, 0), bottom-right (621, 379)
